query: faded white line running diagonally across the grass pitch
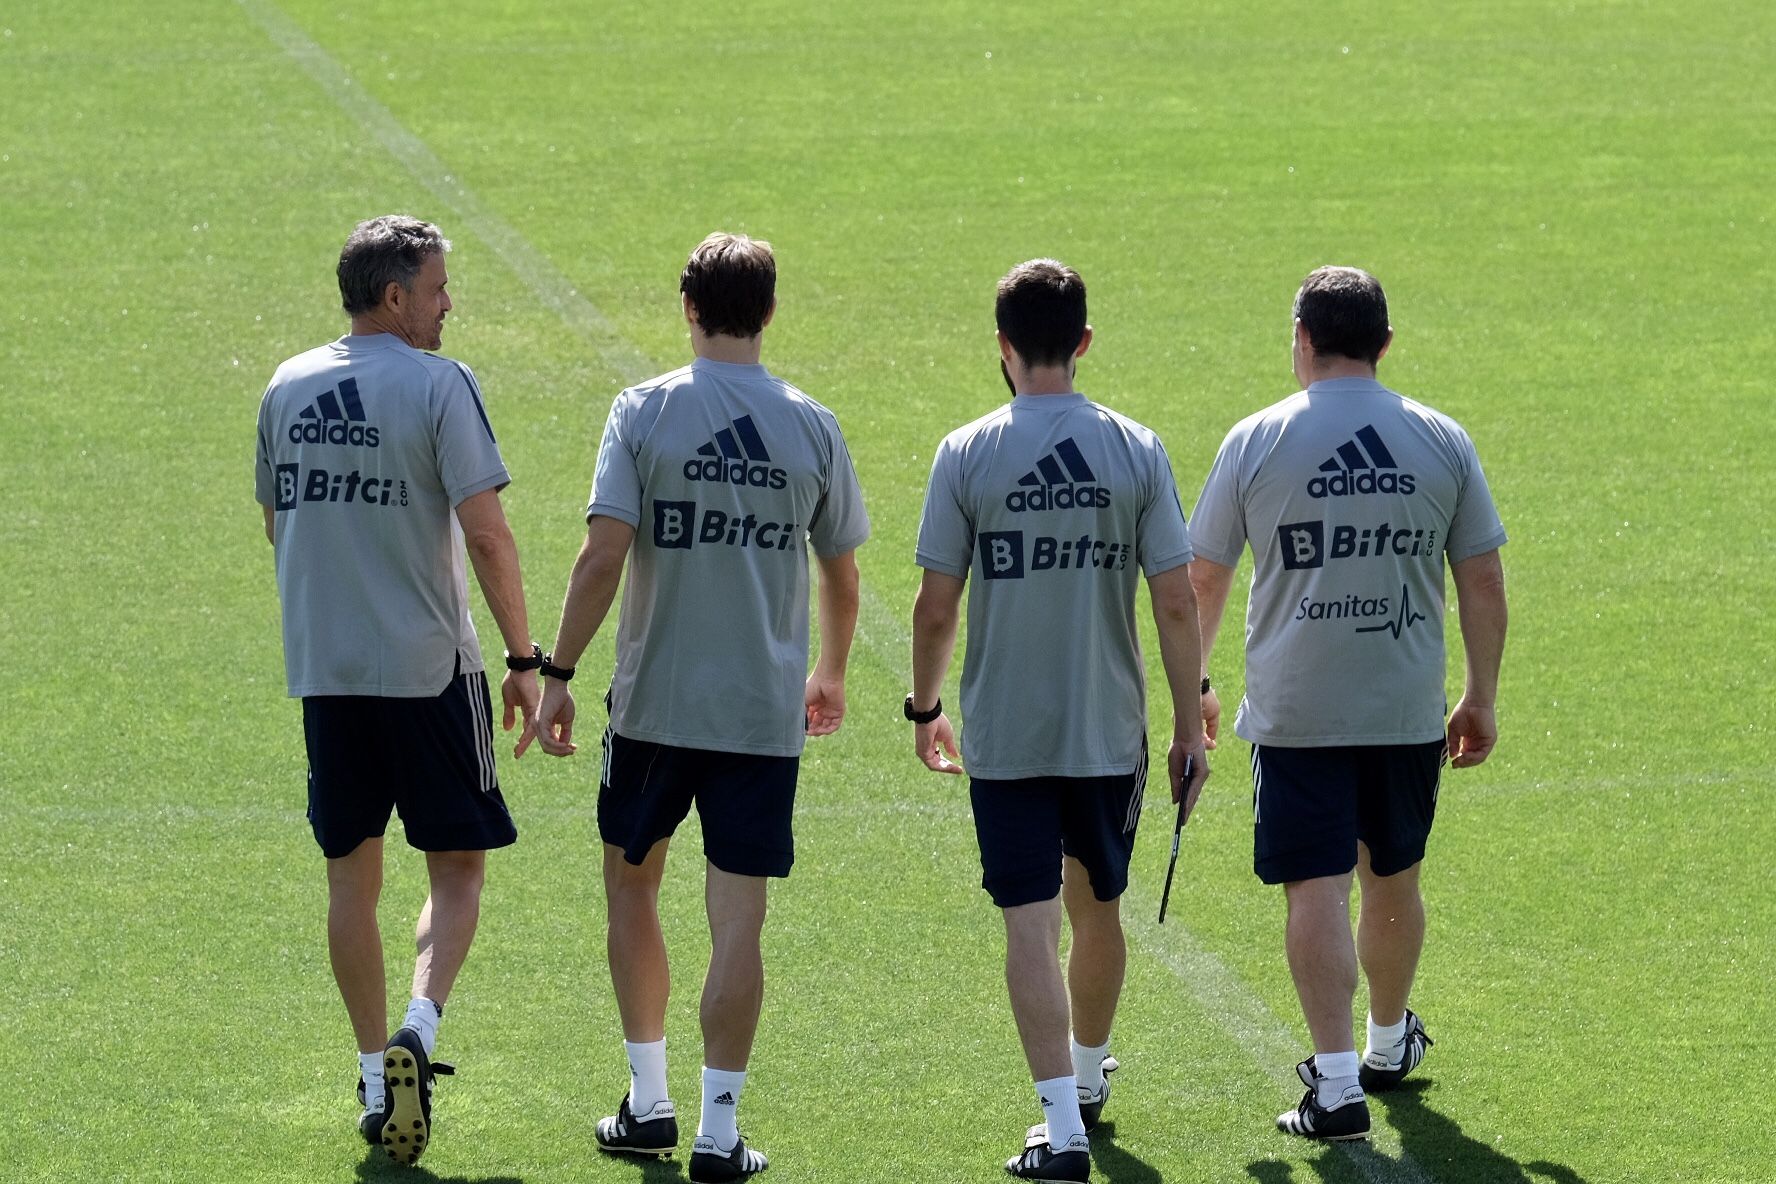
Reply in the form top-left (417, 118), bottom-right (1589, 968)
top-left (236, 0), bottom-right (1431, 1184)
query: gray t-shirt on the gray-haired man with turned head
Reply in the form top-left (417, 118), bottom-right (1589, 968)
top-left (254, 334), bottom-right (511, 699)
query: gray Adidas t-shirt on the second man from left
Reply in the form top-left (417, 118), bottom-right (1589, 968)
top-left (586, 359), bottom-right (870, 756)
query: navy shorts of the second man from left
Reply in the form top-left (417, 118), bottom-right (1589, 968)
top-left (599, 728), bottom-right (801, 877)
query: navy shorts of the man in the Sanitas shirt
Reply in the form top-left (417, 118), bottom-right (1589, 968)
top-left (1252, 740), bottom-right (1449, 884)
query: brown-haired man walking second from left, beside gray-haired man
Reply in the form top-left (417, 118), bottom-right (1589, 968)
top-left (538, 234), bottom-right (868, 1184)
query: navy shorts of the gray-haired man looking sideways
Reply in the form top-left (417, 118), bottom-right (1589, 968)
top-left (302, 671), bottom-right (519, 859)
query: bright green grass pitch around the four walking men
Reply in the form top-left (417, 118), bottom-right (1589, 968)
top-left (0, 0), bottom-right (1776, 1184)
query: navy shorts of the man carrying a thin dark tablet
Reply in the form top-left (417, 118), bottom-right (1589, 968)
top-left (968, 746), bottom-right (1147, 909)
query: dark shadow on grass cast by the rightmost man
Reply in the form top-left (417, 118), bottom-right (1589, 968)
top-left (1245, 1081), bottom-right (1586, 1184)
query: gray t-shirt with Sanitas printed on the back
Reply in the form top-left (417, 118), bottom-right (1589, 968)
top-left (1190, 378), bottom-right (1504, 747)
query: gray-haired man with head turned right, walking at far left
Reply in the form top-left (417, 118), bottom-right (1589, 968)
top-left (256, 215), bottom-right (542, 1163)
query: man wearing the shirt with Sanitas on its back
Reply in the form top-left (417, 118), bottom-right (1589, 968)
top-left (1190, 266), bottom-right (1506, 1140)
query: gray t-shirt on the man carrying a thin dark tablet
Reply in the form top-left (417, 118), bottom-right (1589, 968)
top-left (916, 394), bottom-right (1192, 779)
